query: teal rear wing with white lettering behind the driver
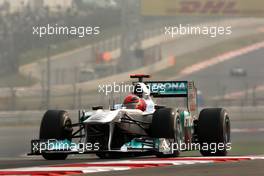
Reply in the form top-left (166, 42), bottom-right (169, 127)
top-left (144, 81), bottom-right (198, 115)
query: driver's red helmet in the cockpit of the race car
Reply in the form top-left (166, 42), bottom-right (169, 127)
top-left (123, 94), bottom-right (147, 111)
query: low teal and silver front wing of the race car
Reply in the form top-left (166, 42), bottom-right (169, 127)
top-left (28, 138), bottom-right (172, 155)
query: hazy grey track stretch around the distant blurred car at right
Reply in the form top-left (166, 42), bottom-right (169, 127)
top-left (183, 49), bottom-right (264, 97)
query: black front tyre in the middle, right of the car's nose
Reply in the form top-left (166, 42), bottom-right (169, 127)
top-left (151, 108), bottom-right (182, 157)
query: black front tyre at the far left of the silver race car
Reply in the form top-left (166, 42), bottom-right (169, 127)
top-left (39, 110), bottom-right (73, 160)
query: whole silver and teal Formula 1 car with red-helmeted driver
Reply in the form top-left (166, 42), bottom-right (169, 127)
top-left (29, 75), bottom-right (231, 160)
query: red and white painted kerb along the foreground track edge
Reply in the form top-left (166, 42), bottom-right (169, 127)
top-left (0, 156), bottom-right (264, 175)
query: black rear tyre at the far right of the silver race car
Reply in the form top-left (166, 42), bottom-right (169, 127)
top-left (197, 108), bottom-right (231, 156)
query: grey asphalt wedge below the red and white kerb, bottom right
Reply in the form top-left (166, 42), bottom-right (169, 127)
top-left (87, 160), bottom-right (264, 176)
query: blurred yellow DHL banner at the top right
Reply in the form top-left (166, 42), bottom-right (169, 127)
top-left (141, 0), bottom-right (264, 16)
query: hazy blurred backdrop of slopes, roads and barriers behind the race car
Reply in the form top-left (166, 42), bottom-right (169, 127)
top-left (0, 0), bottom-right (264, 157)
